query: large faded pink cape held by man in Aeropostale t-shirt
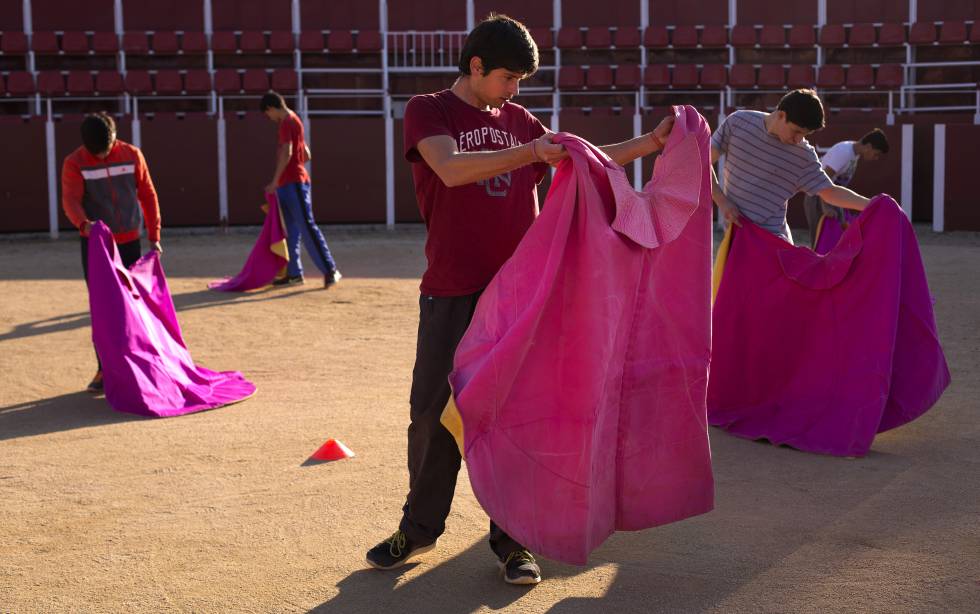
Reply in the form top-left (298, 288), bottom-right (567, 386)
top-left (447, 107), bottom-right (714, 564)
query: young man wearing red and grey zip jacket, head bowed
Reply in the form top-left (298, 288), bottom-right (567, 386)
top-left (61, 113), bottom-right (163, 392)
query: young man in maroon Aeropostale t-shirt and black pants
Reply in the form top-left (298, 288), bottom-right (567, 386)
top-left (367, 14), bottom-right (673, 584)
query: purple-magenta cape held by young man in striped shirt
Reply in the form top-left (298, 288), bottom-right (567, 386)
top-left (708, 195), bottom-right (949, 456)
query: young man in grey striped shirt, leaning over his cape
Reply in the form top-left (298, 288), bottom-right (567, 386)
top-left (711, 89), bottom-right (868, 243)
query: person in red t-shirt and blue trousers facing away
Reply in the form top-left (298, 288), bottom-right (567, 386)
top-left (259, 92), bottom-right (341, 288)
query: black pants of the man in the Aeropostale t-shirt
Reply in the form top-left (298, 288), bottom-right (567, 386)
top-left (399, 292), bottom-right (523, 559)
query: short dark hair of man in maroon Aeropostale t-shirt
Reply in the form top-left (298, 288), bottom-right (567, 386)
top-left (459, 13), bottom-right (538, 75)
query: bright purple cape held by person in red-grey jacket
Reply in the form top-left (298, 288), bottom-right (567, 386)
top-left (88, 222), bottom-right (255, 417)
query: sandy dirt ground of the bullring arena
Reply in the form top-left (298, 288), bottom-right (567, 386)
top-left (0, 227), bottom-right (980, 614)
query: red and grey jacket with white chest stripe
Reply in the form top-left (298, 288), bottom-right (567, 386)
top-left (61, 140), bottom-right (160, 243)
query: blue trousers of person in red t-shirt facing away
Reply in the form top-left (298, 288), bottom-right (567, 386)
top-left (276, 183), bottom-right (337, 277)
